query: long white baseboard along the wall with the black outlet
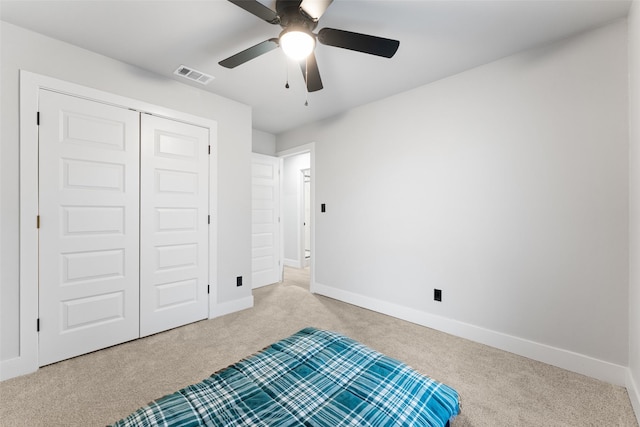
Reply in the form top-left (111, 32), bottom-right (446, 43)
top-left (312, 282), bottom-right (638, 388)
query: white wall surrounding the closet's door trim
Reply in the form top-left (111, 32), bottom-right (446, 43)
top-left (0, 22), bottom-right (251, 360)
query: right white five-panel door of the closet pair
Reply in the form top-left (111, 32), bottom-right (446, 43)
top-left (140, 114), bottom-right (209, 336)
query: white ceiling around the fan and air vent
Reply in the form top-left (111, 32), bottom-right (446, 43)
top-left (0, 0), bottom-right (630, 134)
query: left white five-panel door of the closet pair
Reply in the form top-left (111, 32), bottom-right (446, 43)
top-left (39, 90), bottom-right (139, 366)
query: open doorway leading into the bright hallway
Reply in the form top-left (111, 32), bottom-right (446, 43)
top-left (278, 144), bottom-right (315, 290)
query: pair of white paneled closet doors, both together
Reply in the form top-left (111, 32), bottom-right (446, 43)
top-left (34, 90), bottom-right (209, 366)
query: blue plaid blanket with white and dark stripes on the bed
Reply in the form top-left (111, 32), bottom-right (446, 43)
top-left (114, 328), bottom-right (460, 427)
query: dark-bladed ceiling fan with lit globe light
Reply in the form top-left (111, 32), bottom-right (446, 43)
top-left (219, 0), bottom-right (400, 92)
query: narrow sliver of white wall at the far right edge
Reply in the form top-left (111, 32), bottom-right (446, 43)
top-left (627, 0), bottom-right (640, 419)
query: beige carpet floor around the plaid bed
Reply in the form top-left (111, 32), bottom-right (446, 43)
top-left (0, 269), bottom-right (638, 427)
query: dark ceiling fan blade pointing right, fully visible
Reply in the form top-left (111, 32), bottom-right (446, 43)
top-left (318, 28), bottom-right (400, 58)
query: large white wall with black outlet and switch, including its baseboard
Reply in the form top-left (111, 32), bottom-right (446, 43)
top-left (277, 21), bottom-right (629, 383)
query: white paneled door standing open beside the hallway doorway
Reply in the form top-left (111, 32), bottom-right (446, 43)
top-left (251, 154), bottom-right (281, 288)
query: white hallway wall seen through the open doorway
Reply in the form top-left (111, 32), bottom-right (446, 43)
top-left (281, 153), bottom-right (311, 268)
